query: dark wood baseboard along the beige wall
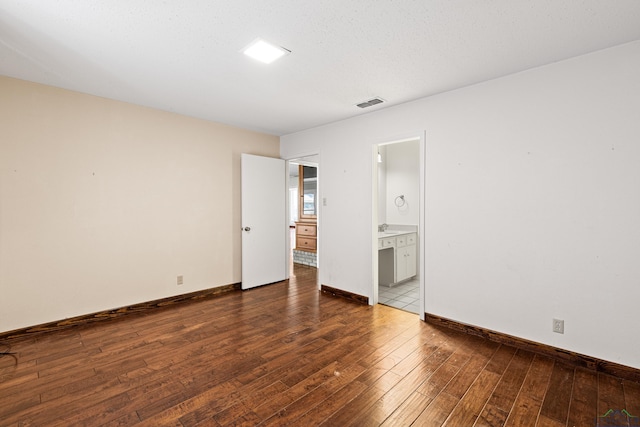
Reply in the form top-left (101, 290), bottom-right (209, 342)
top-left (0, 283), bottom-right (241, 341)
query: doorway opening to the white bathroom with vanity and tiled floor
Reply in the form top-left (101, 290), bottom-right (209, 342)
top-left (373, 136), bottom-right (425, 319)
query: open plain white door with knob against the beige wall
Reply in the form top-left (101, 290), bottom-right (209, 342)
top-left (241, 154), bottom-right (287, 289)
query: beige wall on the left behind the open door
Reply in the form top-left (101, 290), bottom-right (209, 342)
top-left (0, 77), bottom-right (279, 331)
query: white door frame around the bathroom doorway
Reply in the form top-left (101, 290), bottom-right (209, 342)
top-left (371, 131), bottom-right (427, 320)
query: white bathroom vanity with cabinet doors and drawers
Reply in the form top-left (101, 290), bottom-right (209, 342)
top-left (378, 230), bottom-right (418, 285)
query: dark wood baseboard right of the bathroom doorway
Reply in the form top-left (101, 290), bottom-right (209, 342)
top-left (425, 313), bottom-right (640, 382)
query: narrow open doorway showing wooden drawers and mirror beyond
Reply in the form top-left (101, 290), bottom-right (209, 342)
top-left (289, 156), bottom-right (320, 268)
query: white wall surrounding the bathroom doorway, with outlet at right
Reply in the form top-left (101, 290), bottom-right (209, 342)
top-left (281, 42), bottom-right (640, 368)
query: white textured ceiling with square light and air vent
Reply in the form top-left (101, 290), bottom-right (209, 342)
top-left (0, 0), bottom-right (640, 135)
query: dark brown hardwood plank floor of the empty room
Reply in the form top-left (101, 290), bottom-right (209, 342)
top-left (0, 267), bottom-right (640, 427)
